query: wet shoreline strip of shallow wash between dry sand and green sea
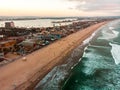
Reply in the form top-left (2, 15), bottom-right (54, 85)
top-left (34, 20), bottom-right (107, 90)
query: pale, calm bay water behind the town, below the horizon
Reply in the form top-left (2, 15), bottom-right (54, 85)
top-left (0, 19), bottom-right (71, 27)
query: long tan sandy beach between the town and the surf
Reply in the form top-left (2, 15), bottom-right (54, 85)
top-left (0, 22), bottom-right (107, 90)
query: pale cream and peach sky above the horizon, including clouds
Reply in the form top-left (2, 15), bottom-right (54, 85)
top-left (0, 0), bottom-right (120, 17)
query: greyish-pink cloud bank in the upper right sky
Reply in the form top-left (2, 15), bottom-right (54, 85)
top-left (68, 0), bottom-right (120, 15)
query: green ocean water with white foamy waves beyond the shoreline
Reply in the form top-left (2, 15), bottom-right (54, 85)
top-left (63, 20), bottom-right (120, 90)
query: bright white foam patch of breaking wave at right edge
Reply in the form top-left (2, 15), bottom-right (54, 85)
top-left (110, 43), bottom-right (120, 64)
